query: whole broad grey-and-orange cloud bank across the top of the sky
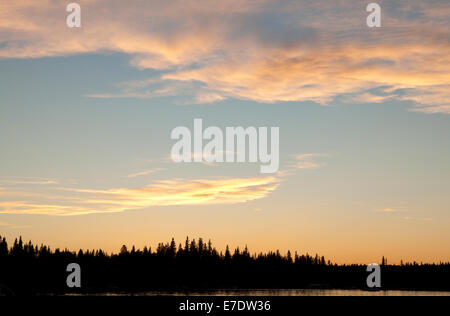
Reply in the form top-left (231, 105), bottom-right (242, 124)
top-left (0, 0), bottom-right (450, 113)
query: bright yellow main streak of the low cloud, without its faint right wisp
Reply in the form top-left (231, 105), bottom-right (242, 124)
top-left (0, 177), bottom-right (280, 215)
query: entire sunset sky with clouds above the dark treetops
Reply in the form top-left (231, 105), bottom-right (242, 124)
top-left (0, 0), bottom-right (450, 264)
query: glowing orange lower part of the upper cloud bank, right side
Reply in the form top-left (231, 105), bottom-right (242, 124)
top-left (162, 44), bottom-right (450, 109)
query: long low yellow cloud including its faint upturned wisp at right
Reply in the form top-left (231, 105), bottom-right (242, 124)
top-left (0, 152), bottom-right (327, 216)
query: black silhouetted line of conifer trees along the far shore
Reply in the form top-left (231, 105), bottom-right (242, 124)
top-left (0, 236), bottom-right (450, 295)
